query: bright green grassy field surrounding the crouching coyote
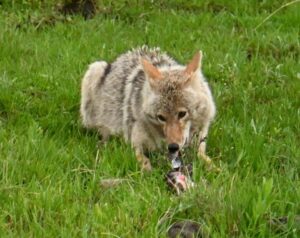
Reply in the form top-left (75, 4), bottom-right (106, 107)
top-left (0, 0), bottom-right (300, 237)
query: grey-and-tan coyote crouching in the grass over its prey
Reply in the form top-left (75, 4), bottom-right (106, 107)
top-left (80, 46), bottom-right (216, 170)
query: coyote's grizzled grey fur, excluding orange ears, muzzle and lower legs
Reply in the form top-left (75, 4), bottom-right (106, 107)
top-left (80, 46), bottom-right (215, 170)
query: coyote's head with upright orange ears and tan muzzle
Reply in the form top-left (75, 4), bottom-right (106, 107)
top-left (142, 52), bottom-right (209, 148)
